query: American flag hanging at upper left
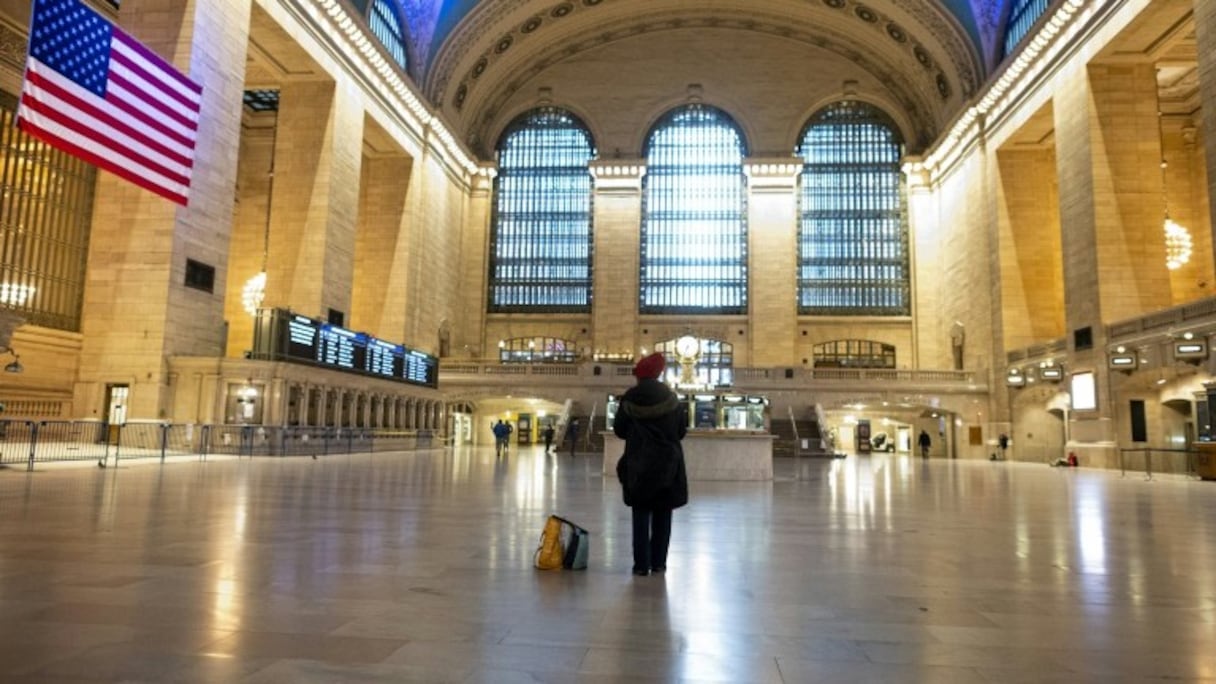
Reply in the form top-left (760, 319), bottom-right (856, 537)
top-left (17, 0), bottom-right (203, 204)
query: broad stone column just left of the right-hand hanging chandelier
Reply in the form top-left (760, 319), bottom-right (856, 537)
top-left (1053, 63), bottom-right (1170, 443)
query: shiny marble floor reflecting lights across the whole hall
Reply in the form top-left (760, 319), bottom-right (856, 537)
top-left (0, 449), bottom-right (1216, 684)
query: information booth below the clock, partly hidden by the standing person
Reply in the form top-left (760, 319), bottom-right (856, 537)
top-left (603, 391), bottom-right (773, 481)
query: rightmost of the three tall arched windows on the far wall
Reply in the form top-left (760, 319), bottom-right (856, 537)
top-left (798, 102), bottom-right (911, 315)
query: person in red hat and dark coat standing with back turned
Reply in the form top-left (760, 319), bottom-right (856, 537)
top-left (612, 352), bottom-right (688, 576)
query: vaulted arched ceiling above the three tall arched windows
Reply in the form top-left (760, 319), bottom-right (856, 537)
top-left (405, 0), bottom-right (996, 156)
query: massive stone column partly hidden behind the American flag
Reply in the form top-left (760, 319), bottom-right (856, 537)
top-left (74, 0), bottom-right (250, 420)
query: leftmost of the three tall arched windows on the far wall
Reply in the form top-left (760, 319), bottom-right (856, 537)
top-left (489, 107), bottom-right (596, 313)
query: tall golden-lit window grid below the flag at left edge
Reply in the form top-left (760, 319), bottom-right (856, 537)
top-left (0, 92), bottom-right (96, 332)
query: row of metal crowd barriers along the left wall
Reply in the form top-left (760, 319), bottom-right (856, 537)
top-left (0, 420), bottom-right (434, 470)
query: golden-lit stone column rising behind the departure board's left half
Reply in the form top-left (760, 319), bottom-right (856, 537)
top-left (265, 82), bottom-right (364, 319)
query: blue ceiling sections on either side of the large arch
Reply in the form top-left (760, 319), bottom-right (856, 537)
top-left (398, 0), bottom-right (1008, 65)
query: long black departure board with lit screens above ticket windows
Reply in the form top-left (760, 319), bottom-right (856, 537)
top-left (253, 309), bottom-right (439, 387)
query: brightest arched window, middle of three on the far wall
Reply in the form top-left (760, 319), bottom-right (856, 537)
top-left (640, 105), bottom-right (748, 314)
